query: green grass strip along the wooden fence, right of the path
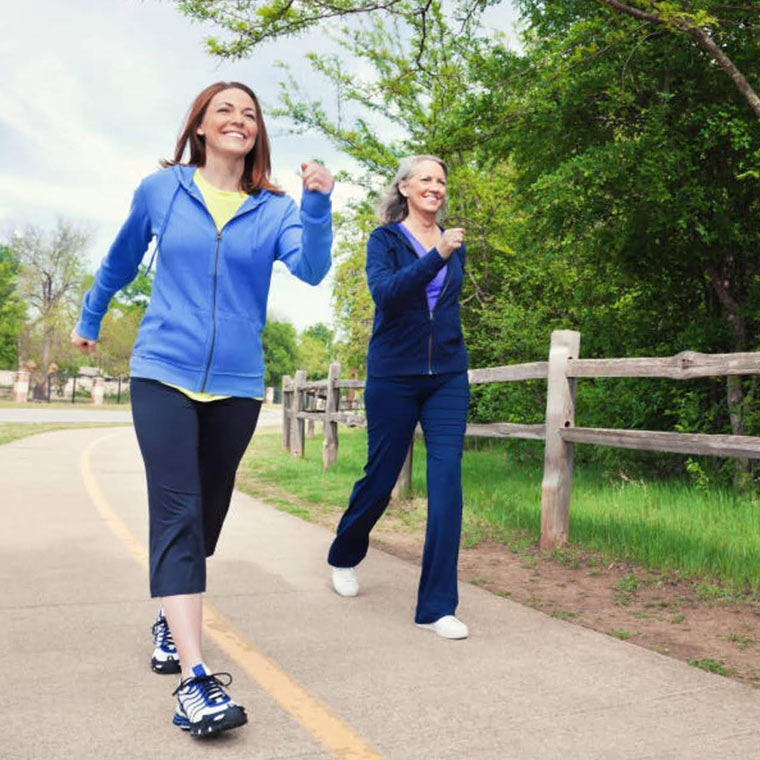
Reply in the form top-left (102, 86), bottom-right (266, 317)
top-left (240, 428), bottom-right (760, 602)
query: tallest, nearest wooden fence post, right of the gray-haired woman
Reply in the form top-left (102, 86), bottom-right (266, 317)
top-left (541, 330), bottom-right (581, 551)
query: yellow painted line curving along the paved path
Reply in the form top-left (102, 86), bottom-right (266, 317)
top-left (79, 433), bottom-right (382, 760)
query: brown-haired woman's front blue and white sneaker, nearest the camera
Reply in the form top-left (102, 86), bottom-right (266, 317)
top-left (172, 665), bottom-right (248, 739)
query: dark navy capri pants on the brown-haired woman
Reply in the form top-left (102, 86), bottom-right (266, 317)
top-left (130, 378), bottom-right (261, 597)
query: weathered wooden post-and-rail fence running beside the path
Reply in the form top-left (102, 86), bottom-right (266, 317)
top-left (282, 330), bottom-right (760, 550)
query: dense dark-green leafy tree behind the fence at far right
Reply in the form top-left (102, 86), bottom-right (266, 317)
top-left (470, 0), bottom-right (760, 480)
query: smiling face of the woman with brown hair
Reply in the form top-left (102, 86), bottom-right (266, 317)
top-left (196, 87), bottom-right (258, 161)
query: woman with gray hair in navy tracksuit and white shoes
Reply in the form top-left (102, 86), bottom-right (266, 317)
top-left (327, 156), bottom-right (469, 639)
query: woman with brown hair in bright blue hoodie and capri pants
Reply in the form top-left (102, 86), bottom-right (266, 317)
top-left (71, 82), bottom-right (333, 737)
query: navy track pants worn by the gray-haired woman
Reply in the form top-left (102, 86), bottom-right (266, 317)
top-left (327, 372), bottom-right (470, 623)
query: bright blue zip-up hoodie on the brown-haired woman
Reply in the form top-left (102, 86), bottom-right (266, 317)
top-left (76, 166), bottom-right (332, 397)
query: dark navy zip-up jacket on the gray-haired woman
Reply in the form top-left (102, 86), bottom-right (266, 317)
top-left (367, 224), bottom-right (468, 377)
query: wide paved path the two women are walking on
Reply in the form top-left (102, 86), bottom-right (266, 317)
top-left (0, 428), bottom-right (760, 760)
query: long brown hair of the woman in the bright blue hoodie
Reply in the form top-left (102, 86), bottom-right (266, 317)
top-left (161, 82), bottom-right (283, 195)
